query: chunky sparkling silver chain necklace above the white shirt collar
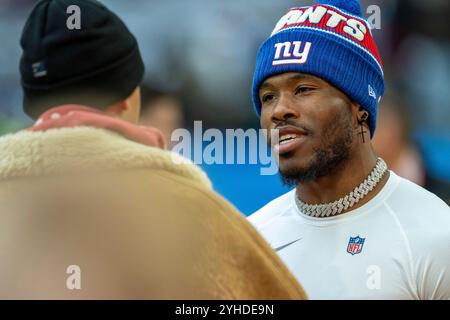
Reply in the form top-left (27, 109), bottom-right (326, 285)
top-left (295, 158), bottom-right (387, 217)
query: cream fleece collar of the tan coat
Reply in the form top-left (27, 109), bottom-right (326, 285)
top-left (0, 108), bottom-right (211, 189)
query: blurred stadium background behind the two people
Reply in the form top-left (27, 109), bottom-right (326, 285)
top-left (0, 0), bottom-right (450, 215)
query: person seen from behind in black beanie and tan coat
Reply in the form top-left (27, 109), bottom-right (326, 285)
top-left (0, 0), bottom-right (305, 299)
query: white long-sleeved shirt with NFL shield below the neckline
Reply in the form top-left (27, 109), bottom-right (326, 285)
top-left (249, 171), bottom-right (450, 299)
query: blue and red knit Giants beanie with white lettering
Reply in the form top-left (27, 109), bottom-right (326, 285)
top-left (252, 0), bottom-right (384, 138)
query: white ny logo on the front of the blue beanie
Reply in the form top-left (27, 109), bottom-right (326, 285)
top-left (272, 41), bottom-right (311, 66)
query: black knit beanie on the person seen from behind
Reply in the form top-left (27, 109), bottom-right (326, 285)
top-left (20, 0), bottom-right (144, 118)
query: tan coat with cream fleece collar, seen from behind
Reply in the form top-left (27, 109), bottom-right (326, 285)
top-left (0, 127), bottom-right (305, 299)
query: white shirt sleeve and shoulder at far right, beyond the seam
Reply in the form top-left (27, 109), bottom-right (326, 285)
top-left (385, 177), bottom-right (450, 299)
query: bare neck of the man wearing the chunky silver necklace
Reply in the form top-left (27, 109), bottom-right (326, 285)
top-left (297, 148), bottom-right (389, 213)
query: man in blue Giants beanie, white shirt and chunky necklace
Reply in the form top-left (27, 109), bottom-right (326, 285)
top-left (249, 0), bottom-right (450, 299)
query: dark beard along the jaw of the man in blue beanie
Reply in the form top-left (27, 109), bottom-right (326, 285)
top-left (280, 110), bottom-right (355, 187)
